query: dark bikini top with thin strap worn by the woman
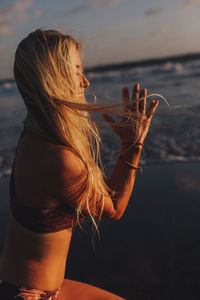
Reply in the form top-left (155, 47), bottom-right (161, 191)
top-left (10, 129), bottom-right (83, 233)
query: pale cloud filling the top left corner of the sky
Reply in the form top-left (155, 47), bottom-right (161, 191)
top-left (0, 0), bottom-right (34, 35)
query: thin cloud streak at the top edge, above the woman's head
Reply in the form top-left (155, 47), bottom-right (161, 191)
top-left (67, 0), bottom-right (125, 15)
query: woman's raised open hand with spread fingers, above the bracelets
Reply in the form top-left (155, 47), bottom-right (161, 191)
top-left (102, 83), bottom-right (159, 145)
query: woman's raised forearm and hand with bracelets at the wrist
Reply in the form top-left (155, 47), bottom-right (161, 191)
top-left (103, 84), bottom-right (158, 219)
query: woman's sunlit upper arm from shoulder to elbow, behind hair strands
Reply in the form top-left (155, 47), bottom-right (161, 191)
top-left (50, 149), bottom-right (116, 219)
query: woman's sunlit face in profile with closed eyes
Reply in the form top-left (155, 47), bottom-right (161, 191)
top-left (73, 50), bottom-right (90, 94)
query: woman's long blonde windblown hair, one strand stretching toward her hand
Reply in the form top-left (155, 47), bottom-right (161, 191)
top-left (14, 29), bottom-right (166, 228)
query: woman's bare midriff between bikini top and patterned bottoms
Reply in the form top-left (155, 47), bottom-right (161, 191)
top-left (0, 215), bottom-right (72, 290)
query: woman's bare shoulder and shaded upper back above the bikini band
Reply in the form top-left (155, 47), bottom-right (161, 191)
top-left (14, 134), bottom-right (86, 205)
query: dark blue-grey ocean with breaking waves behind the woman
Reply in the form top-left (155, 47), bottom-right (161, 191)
top-left (0, 57), bottom-right (200, 178)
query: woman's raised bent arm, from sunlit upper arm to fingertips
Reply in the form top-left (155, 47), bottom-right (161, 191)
top-left (52, 85), bottom-right (158, 220)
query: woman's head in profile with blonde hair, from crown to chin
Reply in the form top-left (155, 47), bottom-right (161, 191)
top-left (14, 29), bottom-right (89, 109)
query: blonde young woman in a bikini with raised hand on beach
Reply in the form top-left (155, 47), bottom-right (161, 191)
top-left (0, 30), bottom-right (158, 300)
